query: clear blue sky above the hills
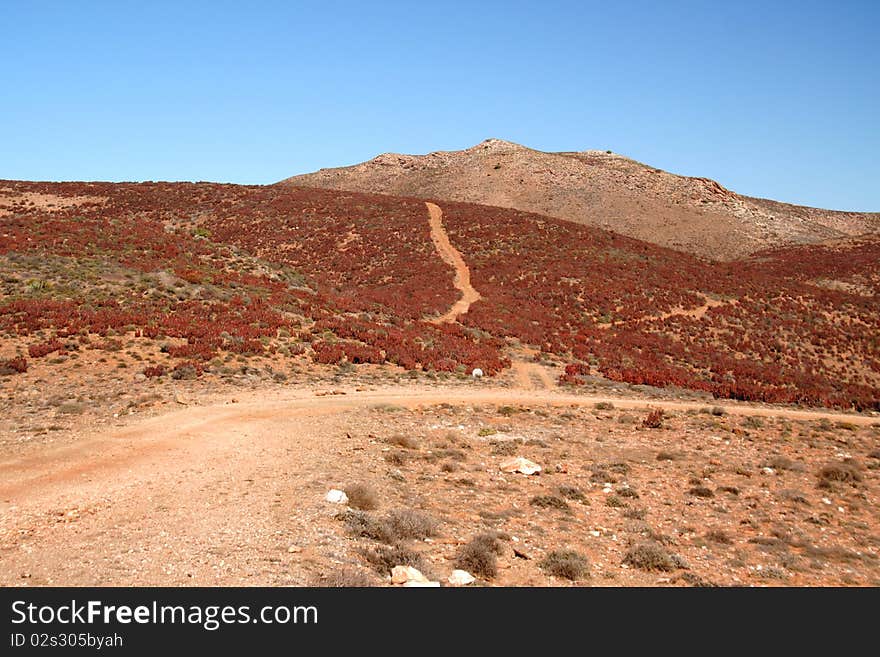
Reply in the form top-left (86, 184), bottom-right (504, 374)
top-left (0, 0), bottom-right (880, 211)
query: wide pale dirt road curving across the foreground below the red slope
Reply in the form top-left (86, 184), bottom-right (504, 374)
top-left (0, 380), bottom-right (877, 586)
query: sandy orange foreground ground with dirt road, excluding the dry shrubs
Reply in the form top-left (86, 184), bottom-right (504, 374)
top-left (0, 374), bottom-right (880, 585)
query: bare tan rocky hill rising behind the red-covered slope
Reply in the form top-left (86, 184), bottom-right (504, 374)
top-left (280, 139), bottom-right (880, 259)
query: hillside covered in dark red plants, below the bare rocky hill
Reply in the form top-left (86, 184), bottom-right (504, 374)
top-left (0, 181), bottom-right (880, 410)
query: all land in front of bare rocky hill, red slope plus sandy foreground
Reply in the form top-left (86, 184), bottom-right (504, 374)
top-left (0, 174), bottom-right (880, 586)
